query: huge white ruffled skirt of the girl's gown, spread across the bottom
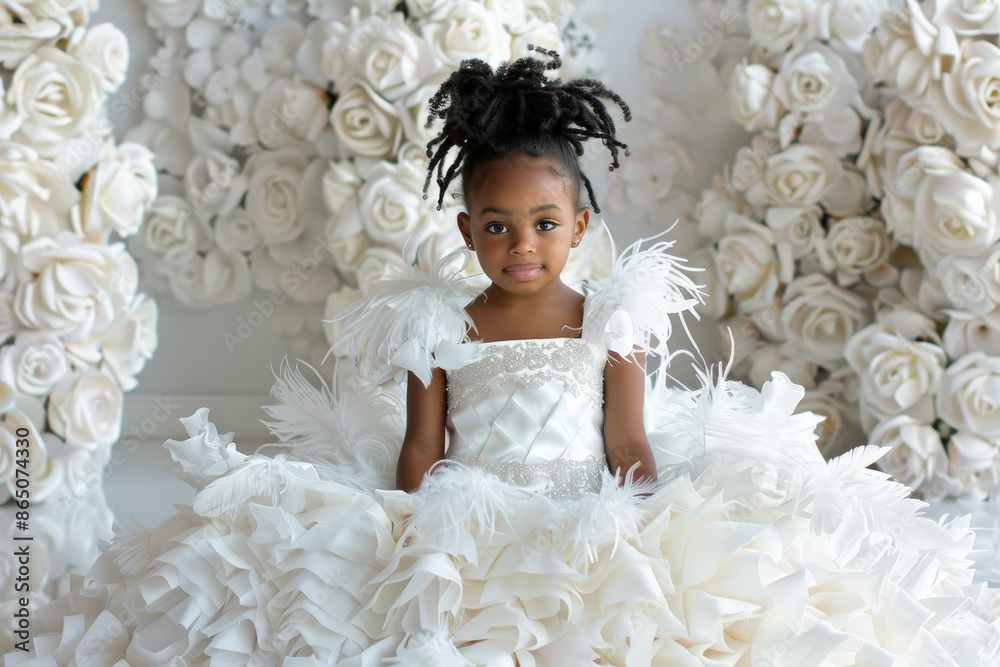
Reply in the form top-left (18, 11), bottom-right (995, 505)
top-left (5, 374), bottom-right (1000, 667)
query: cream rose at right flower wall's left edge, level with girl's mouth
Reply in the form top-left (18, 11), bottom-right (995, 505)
top-left (715, 213), bottom-right (790, 313)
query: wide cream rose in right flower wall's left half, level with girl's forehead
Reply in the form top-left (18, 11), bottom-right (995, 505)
top-left (747, 144), bottom-right (844, 207)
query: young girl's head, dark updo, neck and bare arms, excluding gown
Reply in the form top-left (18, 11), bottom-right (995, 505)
top-left (396, 49), bottom-right (656, 491)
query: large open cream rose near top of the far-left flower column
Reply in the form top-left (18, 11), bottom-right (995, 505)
top-left (7, 46), bottom-right (104, 158)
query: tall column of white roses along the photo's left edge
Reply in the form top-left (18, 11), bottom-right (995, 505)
top-left (0, 0), bottom-right (157, 631)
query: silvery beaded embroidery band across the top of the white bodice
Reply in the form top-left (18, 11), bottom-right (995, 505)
top-left (446, 338), bottom-right (604, 411)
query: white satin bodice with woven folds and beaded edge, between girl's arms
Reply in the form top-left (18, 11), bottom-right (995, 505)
top-left (445, 338), bottom-right (606, 495)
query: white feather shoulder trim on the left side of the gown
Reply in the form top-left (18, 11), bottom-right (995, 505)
top-left (324, 248), bottom-right (480, 386)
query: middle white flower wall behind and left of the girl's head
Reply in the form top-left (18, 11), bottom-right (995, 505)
top-left (127, 0), bottom-right (607, 364)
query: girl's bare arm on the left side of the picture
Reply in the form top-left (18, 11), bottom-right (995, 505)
top-left (396, 368), bottom-right (448, 493)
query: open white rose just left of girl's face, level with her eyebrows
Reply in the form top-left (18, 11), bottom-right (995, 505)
top-left (358, 162), bottom-right (434, 249)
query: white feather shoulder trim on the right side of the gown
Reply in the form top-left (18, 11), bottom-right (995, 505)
top-left (583, 223), bottom-right (705, 360)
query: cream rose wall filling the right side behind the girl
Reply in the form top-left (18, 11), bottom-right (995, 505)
top-left (632, 0), bottom-right (1000, 500)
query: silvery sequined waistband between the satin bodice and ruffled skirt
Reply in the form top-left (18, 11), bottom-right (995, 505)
top-left (446, 455), bottom-right (608, 500)
